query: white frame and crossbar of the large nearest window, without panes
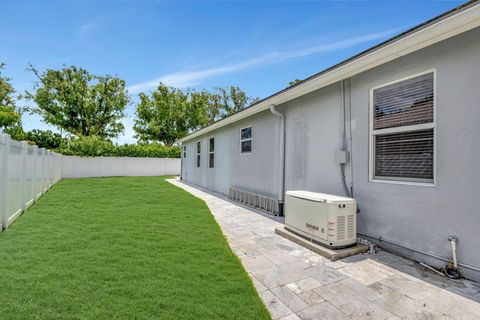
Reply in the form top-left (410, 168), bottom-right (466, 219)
top-left (368, 69), bottom-right (437, 187)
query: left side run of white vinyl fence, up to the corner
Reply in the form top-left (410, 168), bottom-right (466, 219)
top-left (0, 134), bottom-right (62, 231)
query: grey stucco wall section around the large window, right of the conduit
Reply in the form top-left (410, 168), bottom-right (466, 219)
top-left (351, 28), bottom-right (480, 278)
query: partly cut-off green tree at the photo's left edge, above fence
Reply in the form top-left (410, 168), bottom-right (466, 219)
top-left (0, 63), bottom-right (21, 130)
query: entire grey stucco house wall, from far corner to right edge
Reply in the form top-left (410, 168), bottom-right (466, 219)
top-left (182, 28), bottom-right (480, 279)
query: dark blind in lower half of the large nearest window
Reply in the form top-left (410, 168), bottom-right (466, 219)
top-left (375, 129), bottom-right (434, 182)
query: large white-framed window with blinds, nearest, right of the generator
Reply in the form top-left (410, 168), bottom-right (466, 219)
top-left (371, 71), bottom-right (435, 183)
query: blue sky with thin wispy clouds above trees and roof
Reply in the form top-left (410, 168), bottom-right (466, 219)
top-left (0, 0), bottom-right (462, 143)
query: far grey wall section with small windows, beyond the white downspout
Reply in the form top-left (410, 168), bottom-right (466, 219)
top-left (182, 111), bottom-right (280, 199)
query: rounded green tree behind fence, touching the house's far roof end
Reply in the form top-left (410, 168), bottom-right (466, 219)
top-left (133, 83), bottom-right (192, 146)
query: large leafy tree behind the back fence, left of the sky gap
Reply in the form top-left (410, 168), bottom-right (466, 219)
top-left (27, 65), bottom-right (129, 138)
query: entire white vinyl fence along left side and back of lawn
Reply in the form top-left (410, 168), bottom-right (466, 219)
top-left (0, 133), bottom-right (181, 232)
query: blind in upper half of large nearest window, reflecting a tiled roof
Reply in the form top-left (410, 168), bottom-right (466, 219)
top-left (373, 73), bottom-right (433, 130)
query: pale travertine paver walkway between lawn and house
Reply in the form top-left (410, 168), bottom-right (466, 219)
top-left (170, 180), bottom-right (480, 320)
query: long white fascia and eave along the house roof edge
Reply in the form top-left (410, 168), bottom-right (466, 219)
top-left (178, 4), bottom-right (480, 143)
